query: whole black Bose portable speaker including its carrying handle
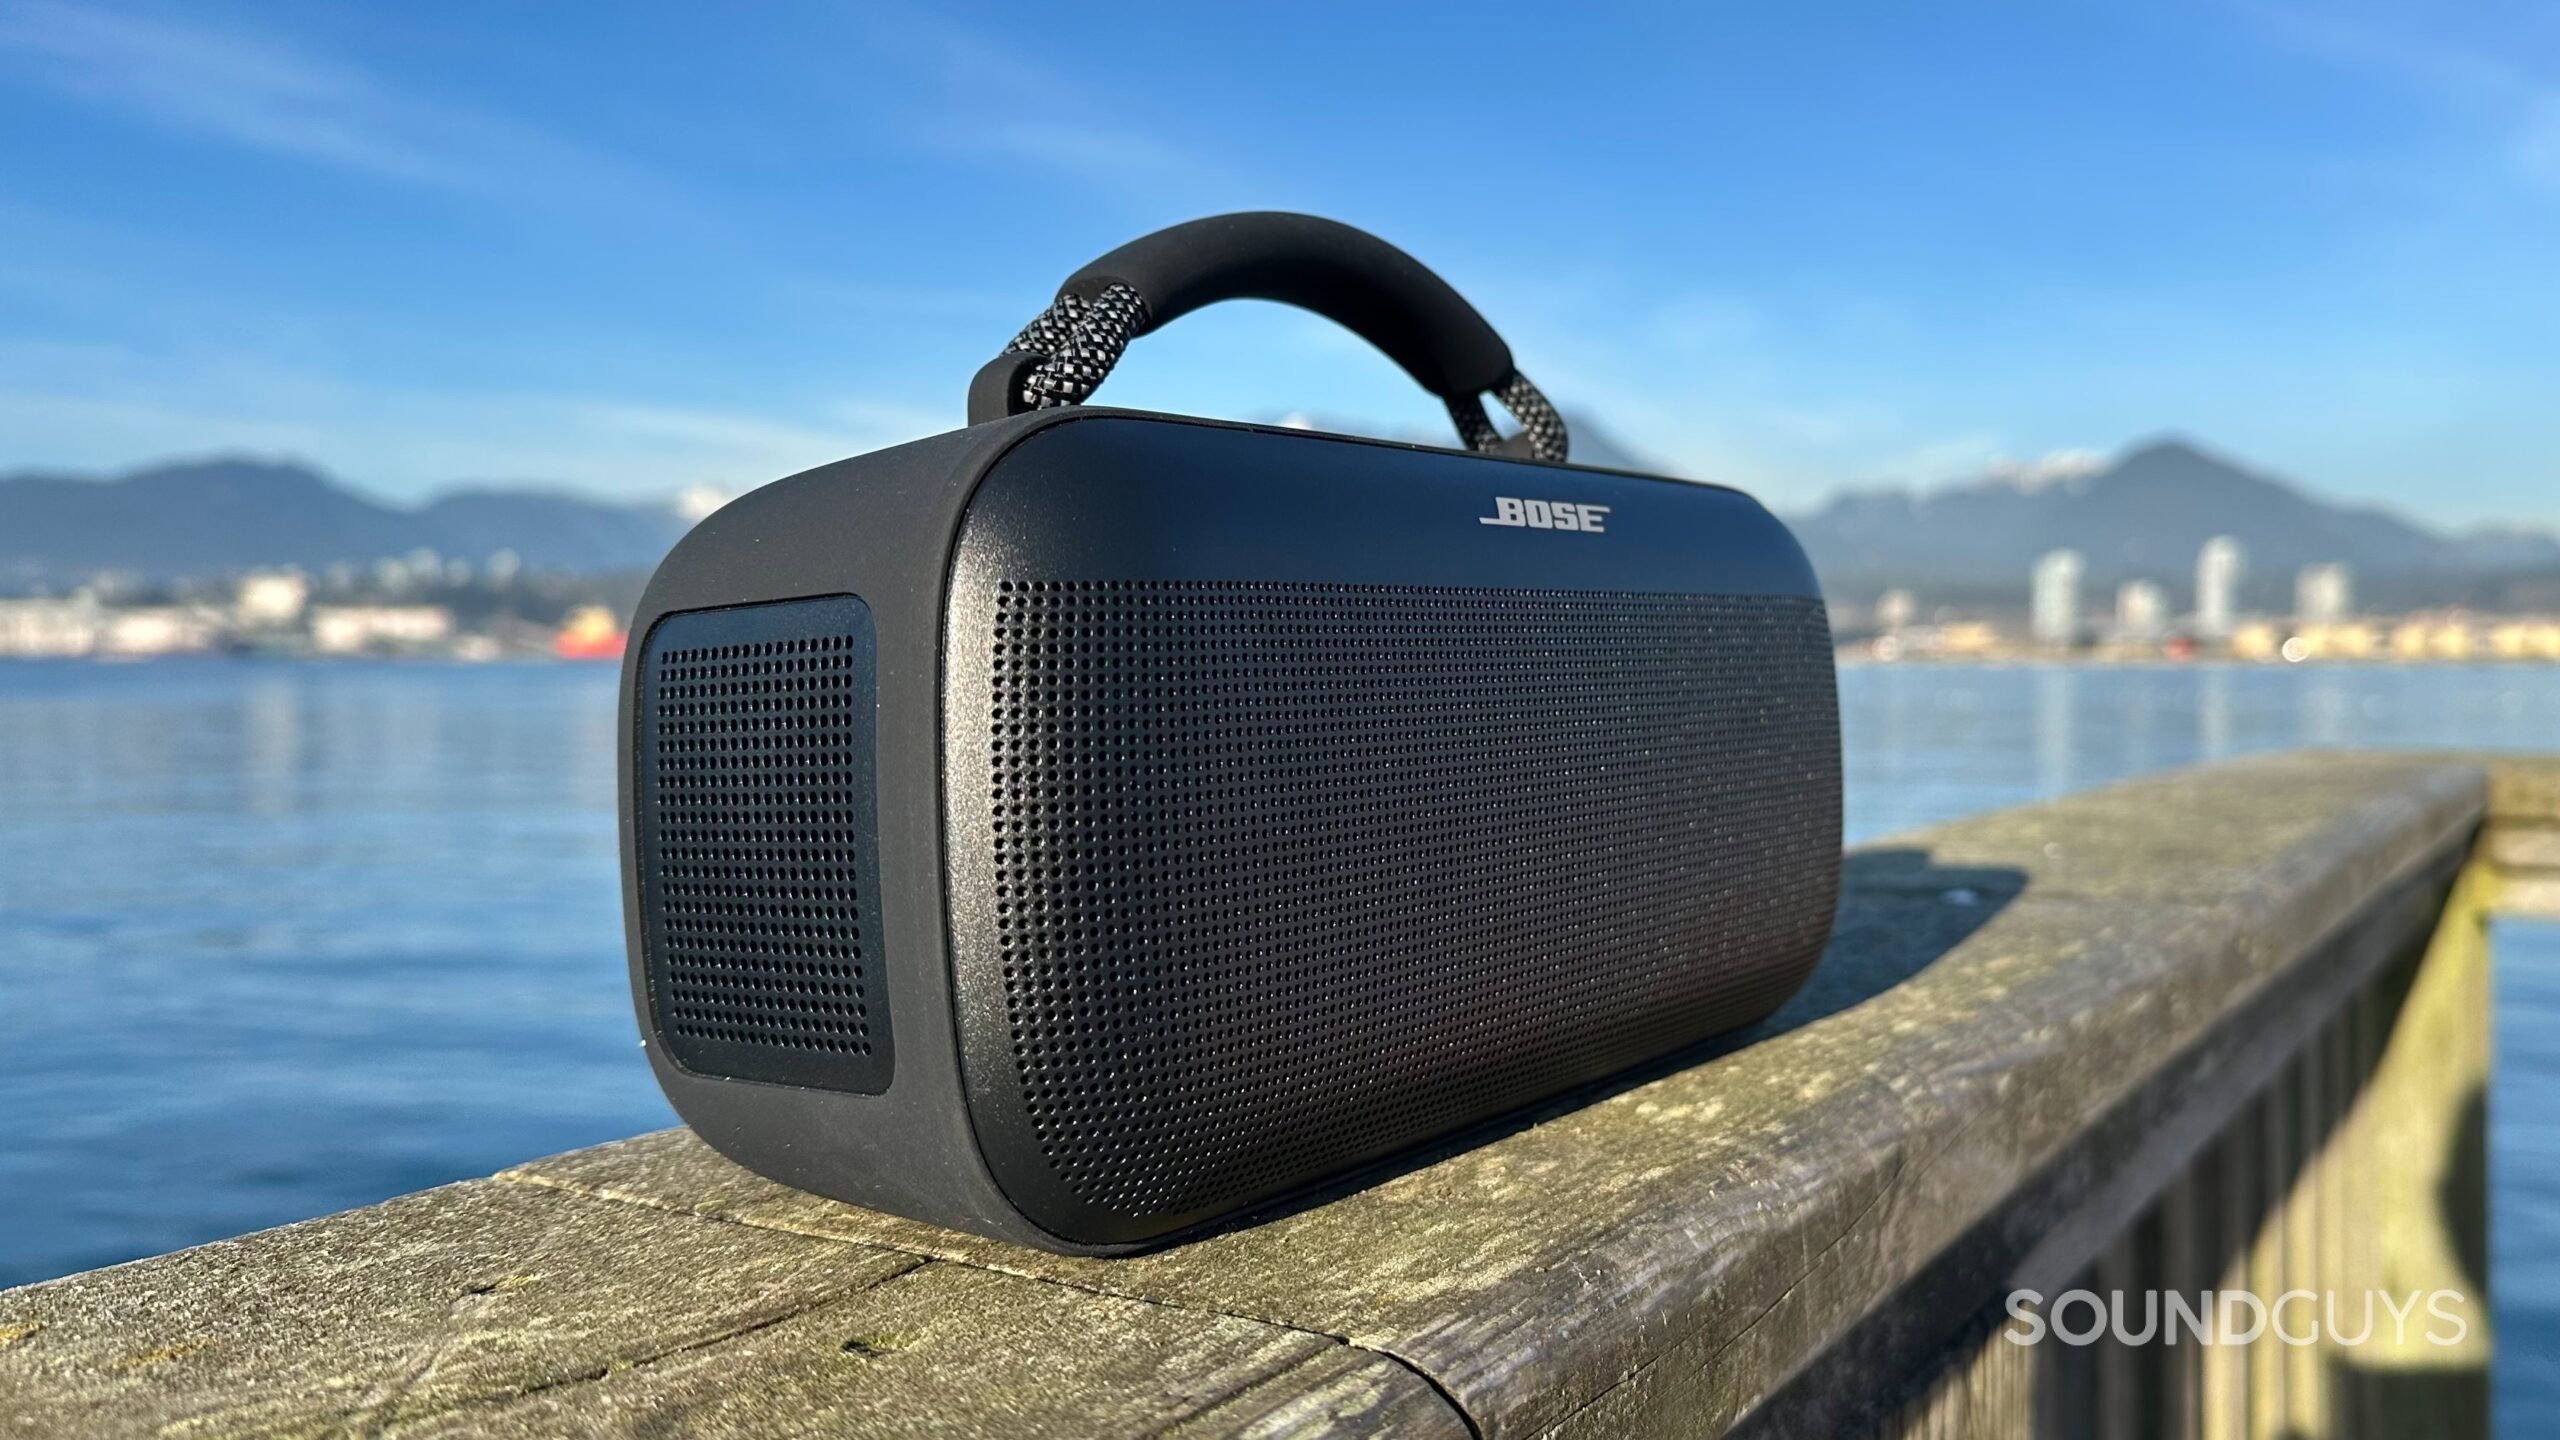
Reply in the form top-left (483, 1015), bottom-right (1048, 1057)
top-left (622, 215), bottom-right (1841, 1253)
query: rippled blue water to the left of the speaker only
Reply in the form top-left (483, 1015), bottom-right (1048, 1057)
top-left (0, 661), bottom-right (650, 1284)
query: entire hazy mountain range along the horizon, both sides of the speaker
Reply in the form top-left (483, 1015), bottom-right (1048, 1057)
top-left (0, 418), bottom-right (2560, 605)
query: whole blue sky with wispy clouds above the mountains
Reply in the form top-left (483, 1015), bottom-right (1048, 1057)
top-left (0, 0), bottom-right (2560, 523)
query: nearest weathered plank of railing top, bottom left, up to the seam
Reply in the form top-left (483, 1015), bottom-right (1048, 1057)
top-left (0, 1181), bottom-right (1464, 1437)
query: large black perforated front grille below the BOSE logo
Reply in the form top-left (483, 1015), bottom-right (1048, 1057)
top-left (988, 582), bottom-right (1841, 1215)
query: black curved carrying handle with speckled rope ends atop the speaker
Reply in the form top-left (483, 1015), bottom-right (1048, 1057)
top-left (968, 210), bottom-right (1569, 461)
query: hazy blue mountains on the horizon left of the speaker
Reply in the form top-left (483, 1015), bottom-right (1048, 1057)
top-left (0, 459), bottom-right (689, 589)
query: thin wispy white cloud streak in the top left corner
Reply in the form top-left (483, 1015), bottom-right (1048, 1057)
top-left (0, 0), bottom-right (665, 197)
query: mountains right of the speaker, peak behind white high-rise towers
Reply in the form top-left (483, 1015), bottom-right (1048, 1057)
top-left (1787, 430), bottom-right (2560, 602)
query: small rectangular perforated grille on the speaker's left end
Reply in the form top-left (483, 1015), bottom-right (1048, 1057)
top-left (632, 597), bottom-right (888, 1092)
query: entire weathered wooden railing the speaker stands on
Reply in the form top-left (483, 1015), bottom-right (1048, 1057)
top-left (0, 756), bottom-right (2560, 1437)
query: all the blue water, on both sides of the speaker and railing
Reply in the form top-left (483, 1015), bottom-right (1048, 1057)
top-left (0, 661), bottom-right (2560, 1404)
